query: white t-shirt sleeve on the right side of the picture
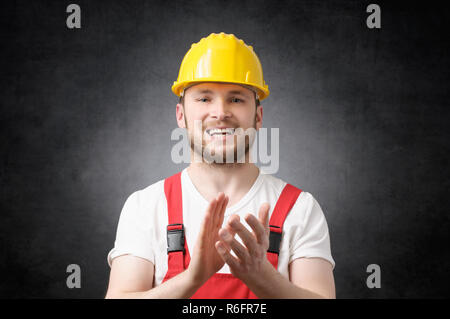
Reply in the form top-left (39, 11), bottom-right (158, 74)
top-left (289, 192), bottom-right (335, 269)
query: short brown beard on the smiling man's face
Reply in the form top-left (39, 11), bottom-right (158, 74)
top-left (185, 115), bottom-right (256, 167)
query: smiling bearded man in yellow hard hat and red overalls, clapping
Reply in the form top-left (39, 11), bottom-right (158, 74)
top-left (106, 33), bottom-right (335, 298)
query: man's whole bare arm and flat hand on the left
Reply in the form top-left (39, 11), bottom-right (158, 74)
top-left (106, 193), bottom-right (234, 298)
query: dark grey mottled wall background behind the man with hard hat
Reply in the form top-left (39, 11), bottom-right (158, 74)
top-left (0, 0), bottom-right (450, 298)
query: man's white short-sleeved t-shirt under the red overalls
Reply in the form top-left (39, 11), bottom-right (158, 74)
top-left (108, 168), bottom-right (335, 286)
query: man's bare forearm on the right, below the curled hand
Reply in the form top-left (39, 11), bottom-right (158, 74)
top-left (245, 263), bottom-right (331, 299)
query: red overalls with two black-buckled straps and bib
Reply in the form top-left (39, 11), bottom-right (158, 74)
top-left (163, 172), bottom-right (302, 299)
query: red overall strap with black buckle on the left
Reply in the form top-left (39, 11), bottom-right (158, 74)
top-left (164, 172), bottom-right (189, 278)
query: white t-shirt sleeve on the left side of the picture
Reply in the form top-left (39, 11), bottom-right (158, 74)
top-left (107, 191), bottom-right (155, 267)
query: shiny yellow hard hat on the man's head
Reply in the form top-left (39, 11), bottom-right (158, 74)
top-left (172, 32), bottom-right (270, 100)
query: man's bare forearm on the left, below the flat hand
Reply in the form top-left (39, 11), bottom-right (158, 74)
top-left (106, 270), bottom-right (202, 299)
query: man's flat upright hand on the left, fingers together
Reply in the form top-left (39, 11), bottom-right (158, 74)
top-left (187, 192), bottom-right (228, 284)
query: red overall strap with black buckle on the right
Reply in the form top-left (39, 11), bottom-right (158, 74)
top-left (267, 184), bottom-right (302, 269)
